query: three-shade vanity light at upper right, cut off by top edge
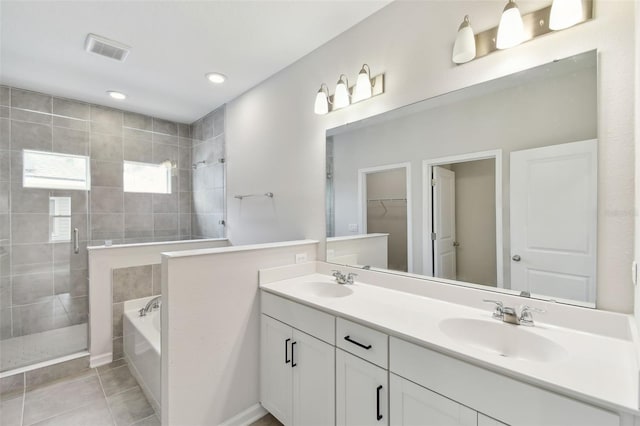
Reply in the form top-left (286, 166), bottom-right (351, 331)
top-left (451, 0), bottom-right (593, 64)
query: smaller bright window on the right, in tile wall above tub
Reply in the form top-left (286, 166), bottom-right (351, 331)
top-left (123, 161), bottom-right (171, 194)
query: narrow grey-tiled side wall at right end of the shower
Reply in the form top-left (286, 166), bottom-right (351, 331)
top-left (191, 106), bottom-right (225, 238)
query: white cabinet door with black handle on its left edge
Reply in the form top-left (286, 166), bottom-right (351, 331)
top-left (294, 329), bottom-right (336, 426)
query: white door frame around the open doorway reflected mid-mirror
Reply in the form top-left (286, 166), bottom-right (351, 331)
top-left (422, 149), bottom-right (504, 288)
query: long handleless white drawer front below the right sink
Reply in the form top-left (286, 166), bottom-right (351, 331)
top-left (389, 337), bottom-right (620, 426)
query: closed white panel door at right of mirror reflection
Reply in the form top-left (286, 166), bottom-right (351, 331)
top-left (510, 140), bottom-right (598, 302)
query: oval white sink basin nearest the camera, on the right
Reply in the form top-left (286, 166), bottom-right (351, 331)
top-left (439, 318), bottom-right (568, 362)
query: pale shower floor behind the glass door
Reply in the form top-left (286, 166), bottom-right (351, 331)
top-left (0, 324), bottom-right (87, 371)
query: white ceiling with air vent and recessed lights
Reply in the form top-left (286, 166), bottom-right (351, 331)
top-left (0, 0), bottom-right (391, 123)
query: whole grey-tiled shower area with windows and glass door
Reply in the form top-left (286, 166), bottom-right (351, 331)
top-left (0, 86), bottom-right (225, 374)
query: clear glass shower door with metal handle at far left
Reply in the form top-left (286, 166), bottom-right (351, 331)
top-left (0, 150), bottom-right (89, 372)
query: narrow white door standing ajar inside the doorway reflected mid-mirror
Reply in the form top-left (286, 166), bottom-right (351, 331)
top-left (432, 166), bottom-right (456, 280)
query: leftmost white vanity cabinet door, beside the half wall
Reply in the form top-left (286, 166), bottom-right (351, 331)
top-left (260, 315), bottom-right (293, 425)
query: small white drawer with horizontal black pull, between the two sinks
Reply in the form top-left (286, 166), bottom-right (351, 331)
top-left (336, 318), bottom-right (388, 369)
